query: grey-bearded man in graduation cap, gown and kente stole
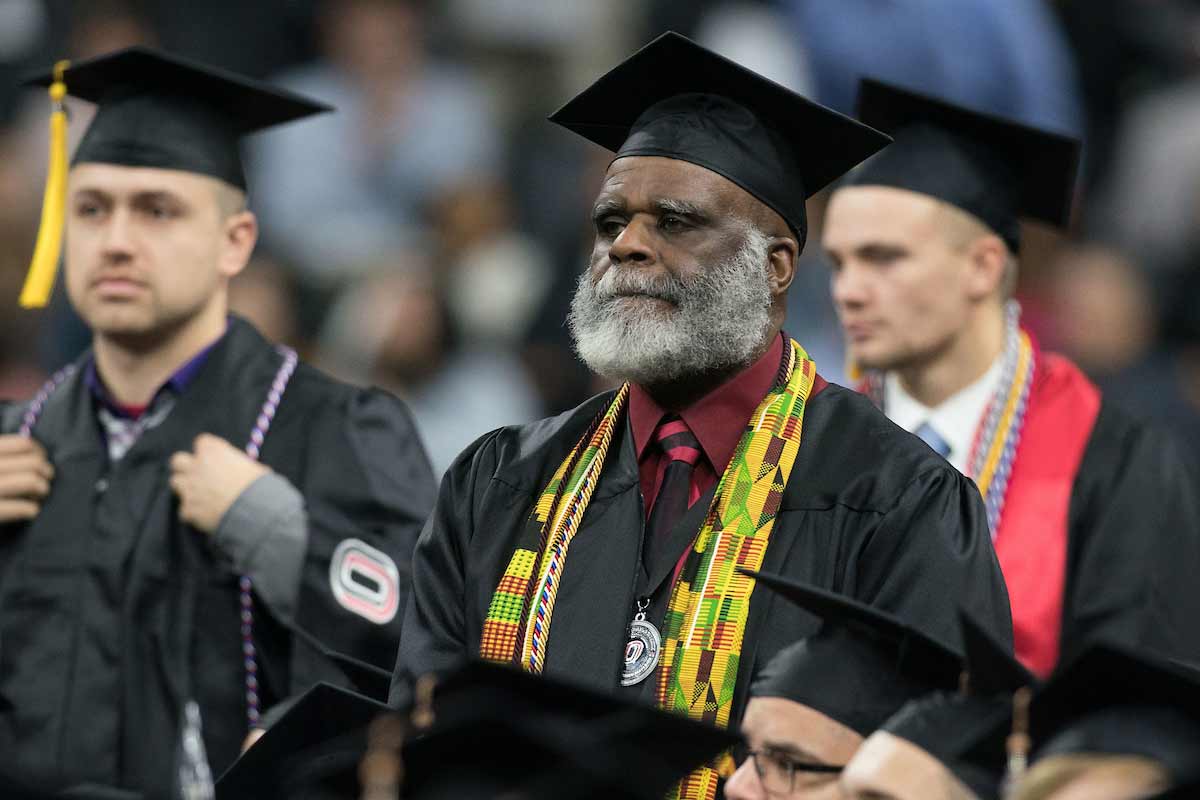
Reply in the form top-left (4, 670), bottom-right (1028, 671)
top-left (392, 34), bottom-right (1010, 798)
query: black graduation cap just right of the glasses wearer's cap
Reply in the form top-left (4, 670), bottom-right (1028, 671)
top-left (880, 608), bottom-right (1037, 798)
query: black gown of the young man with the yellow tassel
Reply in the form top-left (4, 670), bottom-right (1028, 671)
top-left (0, 318), bottom-right (434, 796)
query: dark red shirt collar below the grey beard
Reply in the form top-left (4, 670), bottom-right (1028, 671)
top-left (629, 333), bottom-right (784, 475)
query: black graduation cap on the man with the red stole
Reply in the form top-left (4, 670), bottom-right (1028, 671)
top-left (844, 78), bottom-right (1080, 253)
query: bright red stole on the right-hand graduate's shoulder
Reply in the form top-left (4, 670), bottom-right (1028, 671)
top-left (995, 344), bottom-right (1100, 678)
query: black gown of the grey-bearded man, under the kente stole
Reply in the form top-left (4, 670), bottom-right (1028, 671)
top-left (391, 385), bottom-right (1012, 724)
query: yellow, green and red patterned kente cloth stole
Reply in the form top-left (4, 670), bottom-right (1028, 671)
top-left (480, 342), bottom-right (816, 800)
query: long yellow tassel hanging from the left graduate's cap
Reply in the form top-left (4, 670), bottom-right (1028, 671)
top-left (19, 61), bottom-right (70, 308)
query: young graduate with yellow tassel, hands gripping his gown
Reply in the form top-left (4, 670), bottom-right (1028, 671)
top-left (0, 48), bottom-right (434, 796)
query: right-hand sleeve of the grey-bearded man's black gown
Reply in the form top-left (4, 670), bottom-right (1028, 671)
top-left (854, 465), bottom-right (1013, 650)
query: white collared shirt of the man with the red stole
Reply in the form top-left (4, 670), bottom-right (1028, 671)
top-left (883, 357), bottom-right (1003, 474)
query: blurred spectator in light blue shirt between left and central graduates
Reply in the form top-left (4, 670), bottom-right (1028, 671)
top-left (250, 0), bottom-right (499, 297)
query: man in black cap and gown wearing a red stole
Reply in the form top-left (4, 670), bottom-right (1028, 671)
top-left (822, 80), bottom-right (1200, 676)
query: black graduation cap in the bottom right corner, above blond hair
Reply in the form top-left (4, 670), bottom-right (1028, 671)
top-left (1030, 642), bottom-right (1200, 783)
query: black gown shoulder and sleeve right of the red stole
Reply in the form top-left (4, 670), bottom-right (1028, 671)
top-left (1058, 398), bottom-right (1200, 663)
